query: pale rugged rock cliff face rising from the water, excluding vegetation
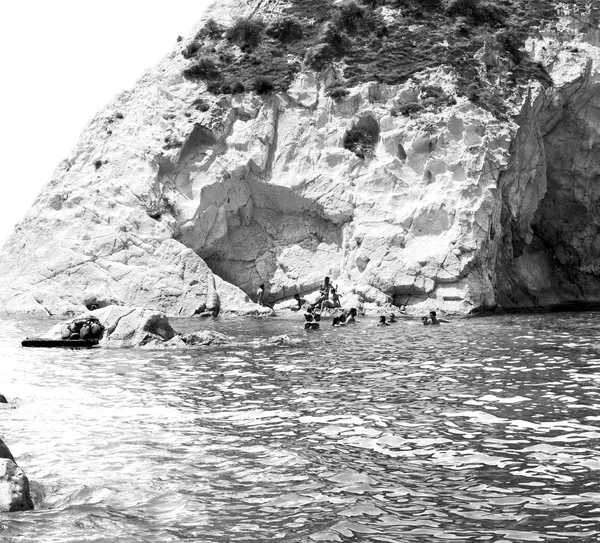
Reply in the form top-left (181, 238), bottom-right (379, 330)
top-left (0, 0), bottom-right (600, 316)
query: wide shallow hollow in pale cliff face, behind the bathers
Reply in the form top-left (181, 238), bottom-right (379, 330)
top-left (178, 175), bottom-right (349, 302)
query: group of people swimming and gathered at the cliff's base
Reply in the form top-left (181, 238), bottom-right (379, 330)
top-left (257, 277), bottom-right (450, 330)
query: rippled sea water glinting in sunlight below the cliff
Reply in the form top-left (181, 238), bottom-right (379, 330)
top-left (0, 313), bottom-right (600, 543)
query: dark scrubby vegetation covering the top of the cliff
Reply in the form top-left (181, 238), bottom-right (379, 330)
top-left (182, 0), bottom-right (588, 118)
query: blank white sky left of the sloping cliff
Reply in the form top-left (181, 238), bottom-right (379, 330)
top-left (0, 0), bottom-right (212, 247)
